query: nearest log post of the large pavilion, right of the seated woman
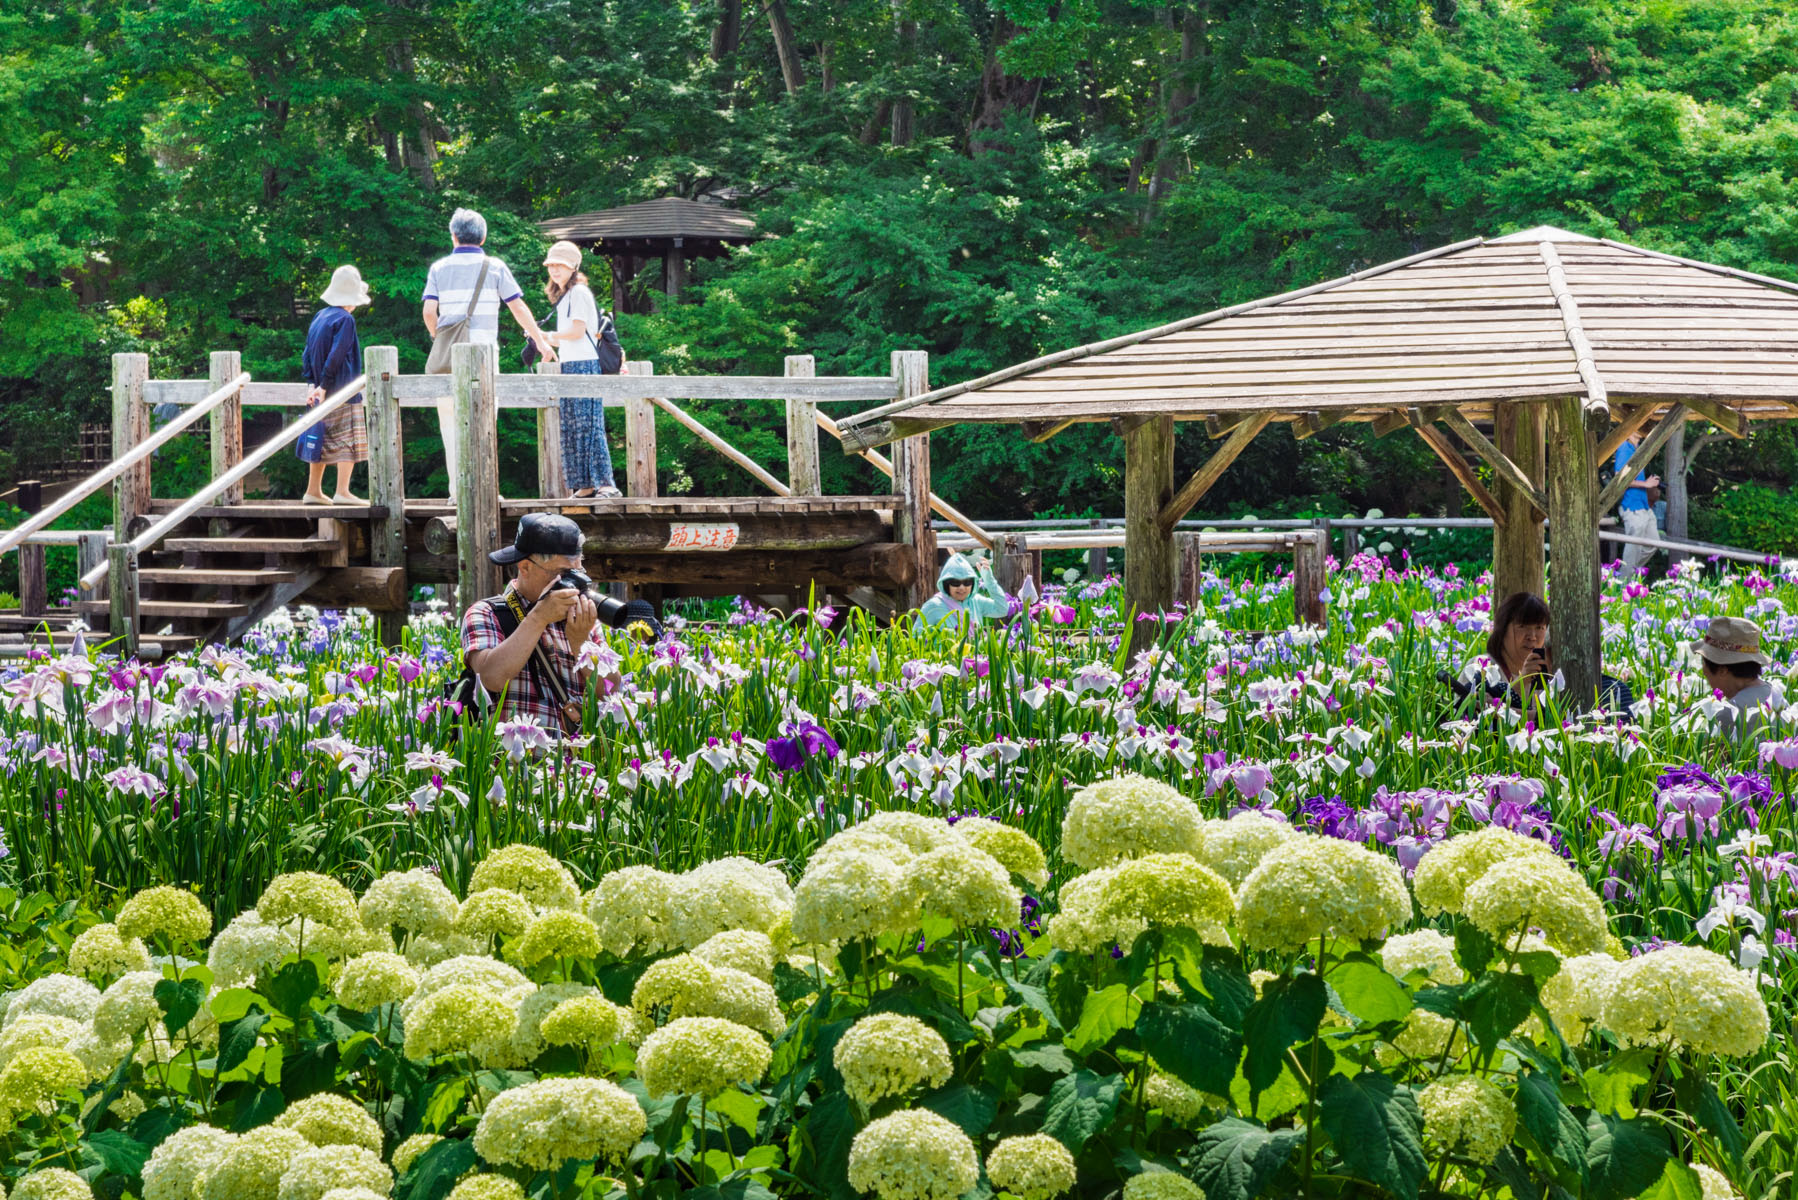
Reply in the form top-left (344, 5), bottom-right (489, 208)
top-left (1546, 396), bottom-right (1598, 709)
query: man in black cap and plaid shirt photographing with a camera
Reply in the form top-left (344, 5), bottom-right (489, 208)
top-left (462, 513), bottom-right (611, 734)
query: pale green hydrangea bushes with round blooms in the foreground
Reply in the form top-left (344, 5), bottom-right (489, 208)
top-left (0, 788), bottom-right (1769, 1200)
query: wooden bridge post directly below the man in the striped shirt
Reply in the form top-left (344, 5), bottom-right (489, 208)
top-left (450, 342), bottom-right (505, 612)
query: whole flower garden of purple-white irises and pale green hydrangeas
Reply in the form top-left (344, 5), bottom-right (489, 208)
top-left (0, 556), bottom-right (1798, 1200)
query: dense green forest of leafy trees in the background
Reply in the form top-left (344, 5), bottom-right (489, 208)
top-left (0, 0), bottom-right (1798, 549)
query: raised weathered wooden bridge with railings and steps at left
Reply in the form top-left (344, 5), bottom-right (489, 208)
top-left (0, 345), bottom-right (992, 653)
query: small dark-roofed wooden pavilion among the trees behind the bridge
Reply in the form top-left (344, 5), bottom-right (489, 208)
top-left (538, 196), bottom-right (761, 313)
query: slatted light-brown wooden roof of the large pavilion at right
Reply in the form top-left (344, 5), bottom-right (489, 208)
top-left (841, 227), bottom-right (1798, 444)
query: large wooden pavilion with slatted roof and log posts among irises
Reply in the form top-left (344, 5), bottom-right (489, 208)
top-left (841, 227), bottom-right (1798, 698)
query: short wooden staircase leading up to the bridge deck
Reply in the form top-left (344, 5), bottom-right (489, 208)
top-left (76, 502), bottom-right (364, 655)
